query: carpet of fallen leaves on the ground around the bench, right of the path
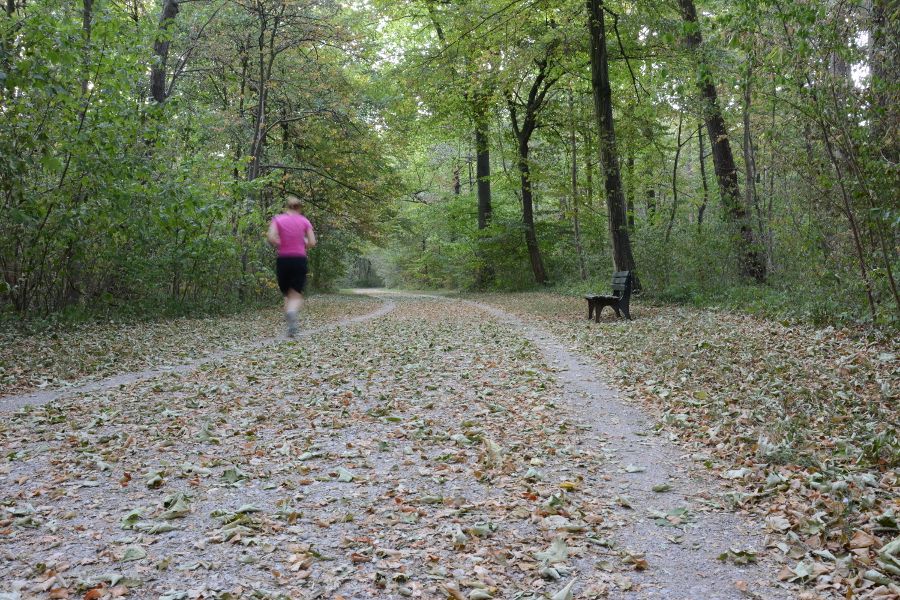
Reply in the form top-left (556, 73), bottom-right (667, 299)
top-left (476, 293), bottom-right (900, 598)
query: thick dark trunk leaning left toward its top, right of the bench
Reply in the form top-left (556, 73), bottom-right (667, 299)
top-left (678, 0), bottom-right (766, 282)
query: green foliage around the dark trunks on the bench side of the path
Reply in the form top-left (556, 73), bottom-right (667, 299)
top-left (362, 1), bottom-right (900, 326)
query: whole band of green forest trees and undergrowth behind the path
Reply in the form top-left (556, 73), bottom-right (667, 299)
top-left (0, 0), bottom-right (900, 324)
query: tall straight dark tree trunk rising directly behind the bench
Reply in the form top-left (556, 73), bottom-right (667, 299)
top-left (587, 0), bottom-right (640, 289)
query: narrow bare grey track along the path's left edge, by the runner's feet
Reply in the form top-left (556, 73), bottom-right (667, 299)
top-left (0, 299), bottom-right (396, 413)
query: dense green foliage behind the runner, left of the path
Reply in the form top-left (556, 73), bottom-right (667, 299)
top-left (0, 0), bottom-right (391, 315)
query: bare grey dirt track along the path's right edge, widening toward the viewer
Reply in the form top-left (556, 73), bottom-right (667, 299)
top-left (466, 301), bottom-right (790, 599)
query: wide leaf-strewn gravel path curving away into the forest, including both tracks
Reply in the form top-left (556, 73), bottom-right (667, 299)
top-left (0, 294), bottom-right (787, 600)
